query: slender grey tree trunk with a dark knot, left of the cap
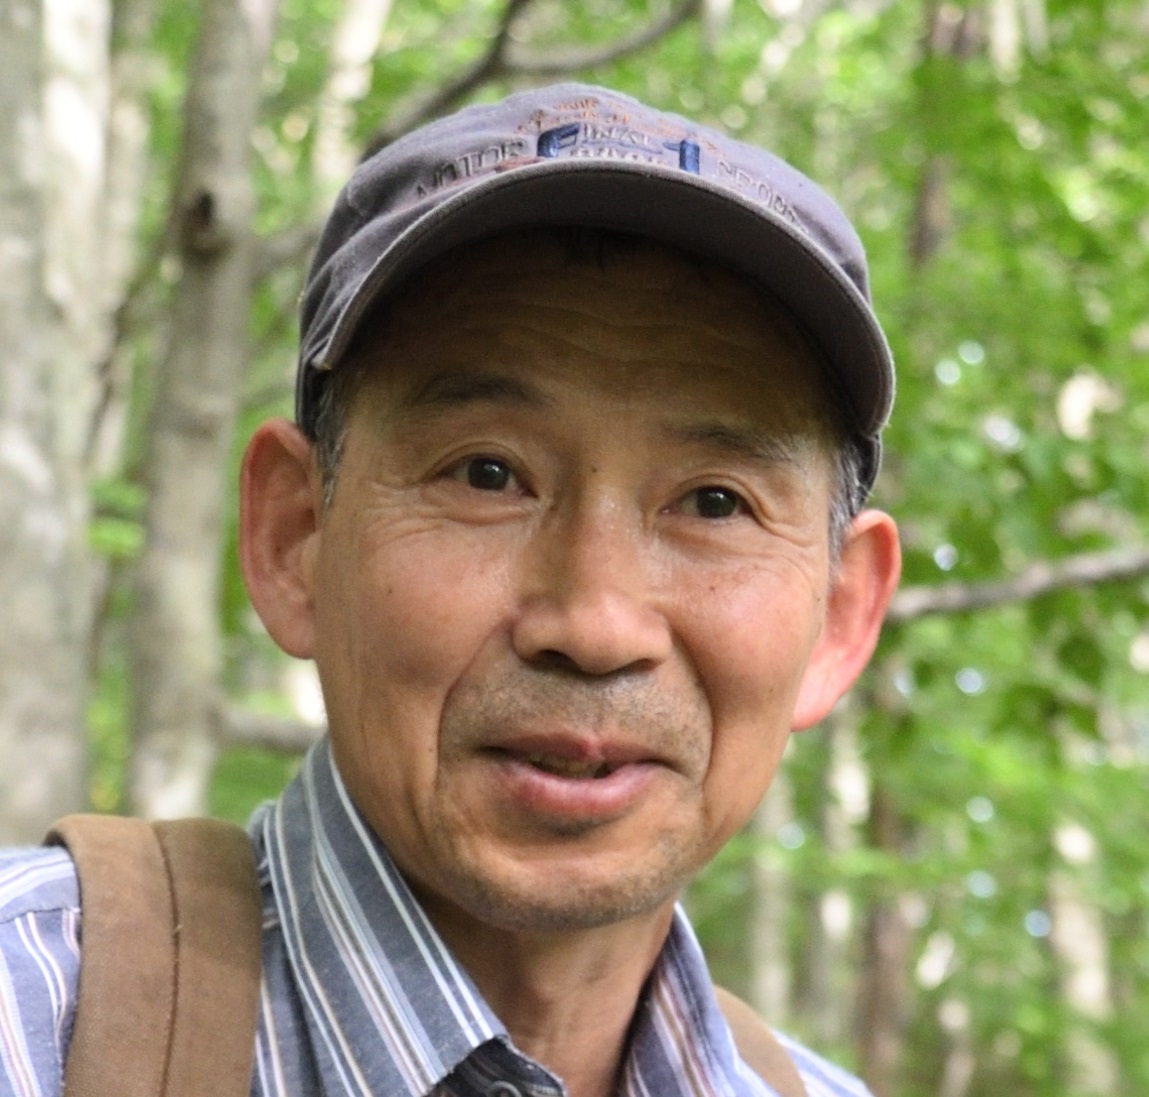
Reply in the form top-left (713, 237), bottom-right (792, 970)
top-left (131, 0), bottom-right (275, 818)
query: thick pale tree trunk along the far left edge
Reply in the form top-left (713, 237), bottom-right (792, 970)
top-left (0, 0), bottom-right (109, 842)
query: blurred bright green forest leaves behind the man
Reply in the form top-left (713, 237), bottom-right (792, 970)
top-left (81, 0), bottom-right (1149, 1097)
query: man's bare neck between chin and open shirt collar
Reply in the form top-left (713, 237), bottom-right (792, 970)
top-left (433, 904), bottom-right (673, 1097)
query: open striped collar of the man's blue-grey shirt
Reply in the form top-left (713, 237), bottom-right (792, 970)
top-left (256, 740), bottom-right (768, 1097)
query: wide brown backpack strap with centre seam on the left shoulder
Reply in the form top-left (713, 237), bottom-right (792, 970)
top-left (46, 816), bottom-right (262, 1097)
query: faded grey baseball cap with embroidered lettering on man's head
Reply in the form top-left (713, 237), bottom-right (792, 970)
top-left (295, 84), bottom-right (894, 489)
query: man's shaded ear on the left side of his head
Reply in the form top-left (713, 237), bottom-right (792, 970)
top-left (239, 419), bottom-right (323, 659)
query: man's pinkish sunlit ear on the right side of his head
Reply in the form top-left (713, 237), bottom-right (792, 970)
top-left (794, 510), bottom-right (902, 731)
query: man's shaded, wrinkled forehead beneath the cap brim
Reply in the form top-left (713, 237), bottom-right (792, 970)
top-left (344, 229), bottom-right (833, 435)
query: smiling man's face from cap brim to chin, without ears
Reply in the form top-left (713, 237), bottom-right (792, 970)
top-left (313, 235), bottom-right (850, 930)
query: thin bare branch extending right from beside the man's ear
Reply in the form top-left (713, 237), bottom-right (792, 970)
top-left (886, 548), bottom-right (1149, 624)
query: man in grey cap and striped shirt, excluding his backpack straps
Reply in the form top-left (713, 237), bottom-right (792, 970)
top-left (0, 85), bottom-right (899, 1097)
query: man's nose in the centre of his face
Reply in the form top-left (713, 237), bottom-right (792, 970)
top-left (512, 505), bottom-right (673, 675)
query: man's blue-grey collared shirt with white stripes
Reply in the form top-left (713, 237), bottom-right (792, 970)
top-left (0, 742), bottom-right (867, 1097)
